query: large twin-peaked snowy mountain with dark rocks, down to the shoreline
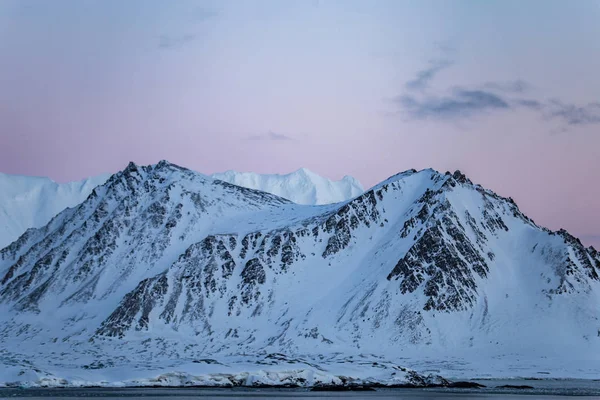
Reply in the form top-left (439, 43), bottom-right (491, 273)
top-left (0, 162), bottom-right (600, 386)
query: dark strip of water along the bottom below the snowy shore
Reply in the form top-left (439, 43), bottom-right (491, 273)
top-left (0, 380), bottom-right (600, 400)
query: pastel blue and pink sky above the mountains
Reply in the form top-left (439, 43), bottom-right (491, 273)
top-left (0, 0), bottom-right (600, 248)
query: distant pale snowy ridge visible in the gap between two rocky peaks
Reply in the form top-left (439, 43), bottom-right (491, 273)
top-left (211, 168), bottom-right (364, 205)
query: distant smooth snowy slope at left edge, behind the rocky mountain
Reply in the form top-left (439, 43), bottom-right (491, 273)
top-left (0, 173), bottom-right (110, 248)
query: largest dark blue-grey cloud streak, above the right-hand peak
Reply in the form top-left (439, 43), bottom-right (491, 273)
top-left (396, 89), bottom-right (510, 119)
